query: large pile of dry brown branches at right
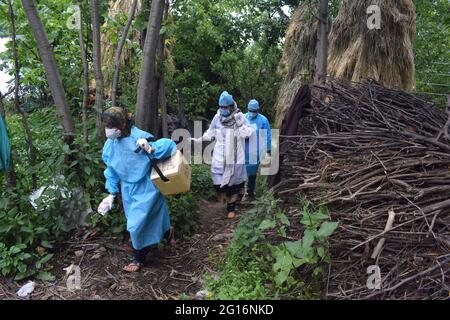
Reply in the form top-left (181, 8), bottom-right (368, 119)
top-left (274, 79), bottom-right (450, 299)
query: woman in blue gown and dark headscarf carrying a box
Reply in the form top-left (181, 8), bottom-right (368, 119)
top-left (98, 107), bottom-right (176, 272)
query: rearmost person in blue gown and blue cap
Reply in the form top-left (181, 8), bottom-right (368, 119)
top-left (245, 99), bottom-right (272, 201)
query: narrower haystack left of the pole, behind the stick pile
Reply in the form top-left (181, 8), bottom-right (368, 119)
top-left (275, 5), bottom-right (318, 127)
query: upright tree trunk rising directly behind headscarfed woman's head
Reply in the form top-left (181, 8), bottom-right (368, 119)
top-left (89, 0), bottom-right (105, 137)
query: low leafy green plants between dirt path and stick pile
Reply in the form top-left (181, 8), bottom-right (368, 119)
top-left (206, 193), bottom-right (337, 299)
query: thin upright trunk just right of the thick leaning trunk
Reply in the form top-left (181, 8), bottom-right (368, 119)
top-left (77, 2), bottom-right (89, 148)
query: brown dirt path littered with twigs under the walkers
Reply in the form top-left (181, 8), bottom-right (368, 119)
top-left (0, 200), bottom-right (243, 299)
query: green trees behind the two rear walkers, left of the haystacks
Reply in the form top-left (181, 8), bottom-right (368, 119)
top-left (167, 0), bottom-right (298, 119)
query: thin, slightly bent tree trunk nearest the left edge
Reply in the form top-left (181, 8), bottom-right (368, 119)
top-left (8, 0), bottom-right (37, 190)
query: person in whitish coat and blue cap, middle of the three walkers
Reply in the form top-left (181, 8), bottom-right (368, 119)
top-left (192, 91), bottom-right (253, 219)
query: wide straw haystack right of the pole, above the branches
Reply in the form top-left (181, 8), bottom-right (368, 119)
top-left (328, 0), bottom-right (416, 91)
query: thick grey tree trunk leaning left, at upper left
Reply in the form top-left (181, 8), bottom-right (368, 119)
top-left (22, 0), bottom-right (75, 145)
